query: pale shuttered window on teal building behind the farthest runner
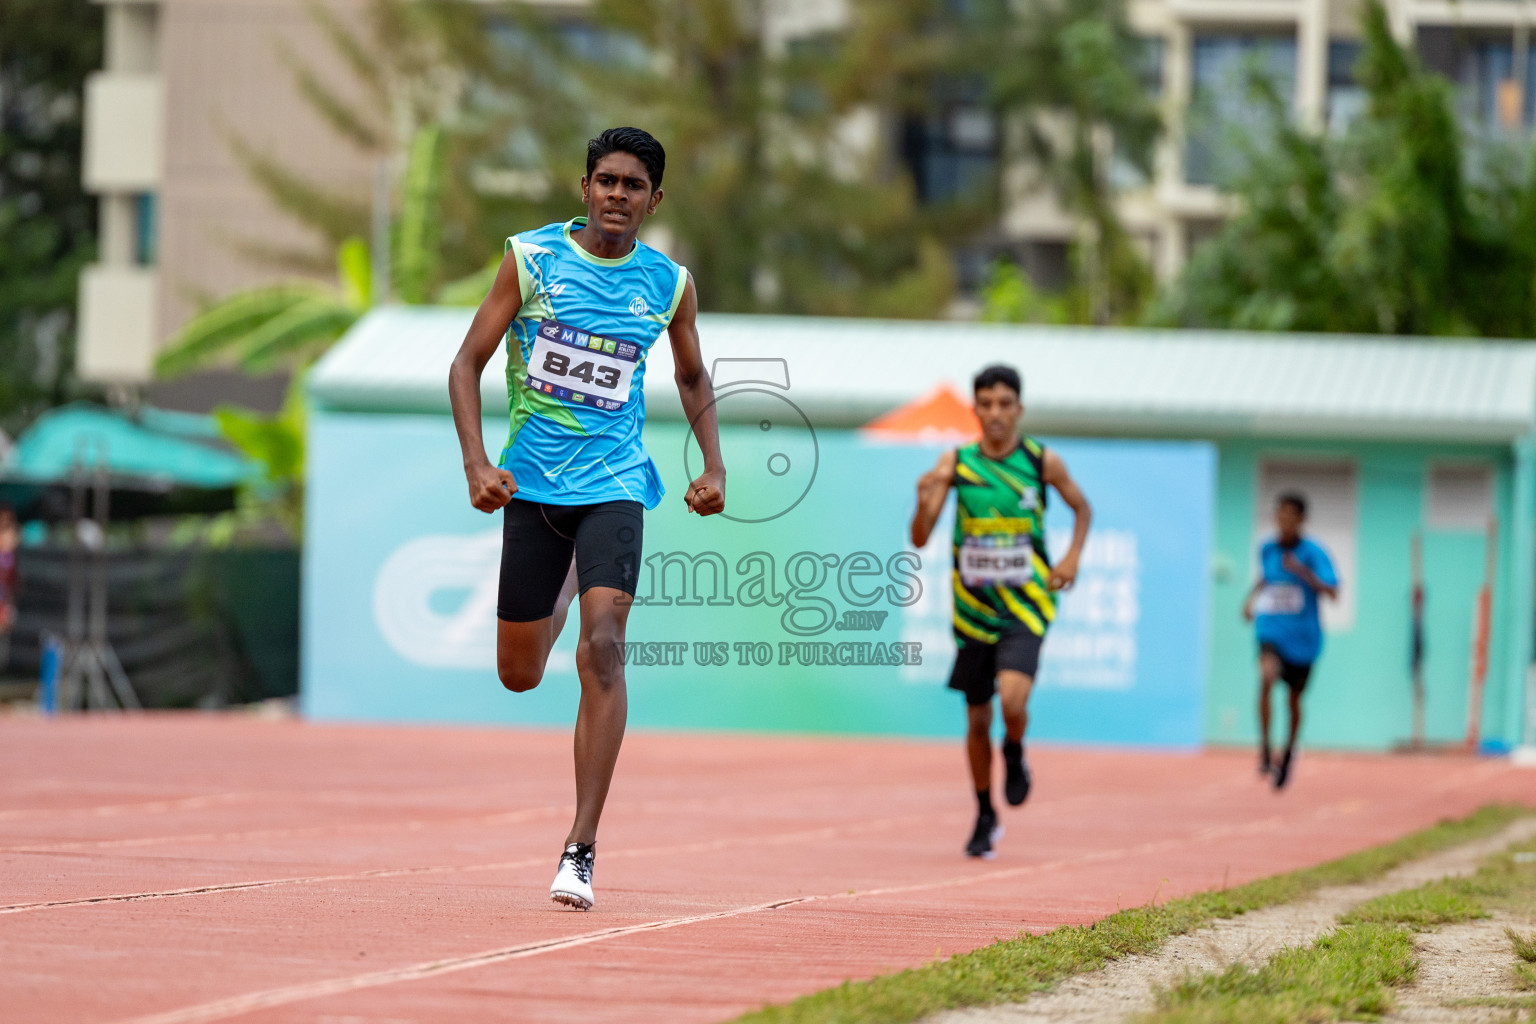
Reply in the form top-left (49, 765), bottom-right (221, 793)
top-left (1252, 459), bottom-right (1359, 633)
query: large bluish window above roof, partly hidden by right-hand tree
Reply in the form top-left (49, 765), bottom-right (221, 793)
top-left (1184, 34), bottom-right (1296, 184)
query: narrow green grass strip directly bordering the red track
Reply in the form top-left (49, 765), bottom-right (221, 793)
top-left (737, 806), bottom-right (1528, 1024)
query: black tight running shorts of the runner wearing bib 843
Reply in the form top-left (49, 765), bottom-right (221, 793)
top-left (496, 497), bottom-right (644, 622)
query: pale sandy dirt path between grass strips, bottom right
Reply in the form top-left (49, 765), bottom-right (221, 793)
top-left (925, 820), bottom-right (1536, 1024)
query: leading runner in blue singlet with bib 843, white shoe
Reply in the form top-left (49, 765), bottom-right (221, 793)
top-left (449, 127), bottom-right (725, 910)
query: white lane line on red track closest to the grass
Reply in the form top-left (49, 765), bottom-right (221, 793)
top-left (108, 800), bottom-right (1367, 1024)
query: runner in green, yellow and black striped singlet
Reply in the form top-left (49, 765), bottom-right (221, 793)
top-left (912, 365), bottom-right (1092, 857)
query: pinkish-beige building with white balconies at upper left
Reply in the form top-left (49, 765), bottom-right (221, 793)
top-left (77, 0), bottom-right (373, 388)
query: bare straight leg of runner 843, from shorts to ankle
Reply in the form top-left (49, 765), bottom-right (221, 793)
top-left (565, 586), bottom-right (634, 844)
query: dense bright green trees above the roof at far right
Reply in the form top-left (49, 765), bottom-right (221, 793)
top-left (1152, 0), bottom-right (1536, 338)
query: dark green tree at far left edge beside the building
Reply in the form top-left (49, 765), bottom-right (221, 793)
top-left (0, 0), bottom-right (101, 430)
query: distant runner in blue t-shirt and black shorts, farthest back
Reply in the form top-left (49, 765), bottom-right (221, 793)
top-left (1243, 494), bottom-right (1339, 789)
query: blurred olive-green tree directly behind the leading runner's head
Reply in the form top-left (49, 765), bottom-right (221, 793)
top-left (485, 0), bottom-right (955, 316)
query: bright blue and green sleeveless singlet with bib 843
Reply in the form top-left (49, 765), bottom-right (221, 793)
top-left (499, 216), bottom-right (688, 508)
